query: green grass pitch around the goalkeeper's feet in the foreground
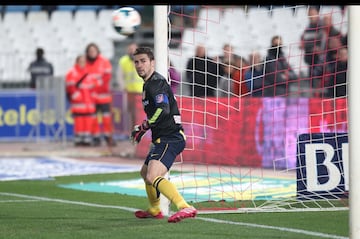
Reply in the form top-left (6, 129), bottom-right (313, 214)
top-left (0, 172), bottom-right (349, 239)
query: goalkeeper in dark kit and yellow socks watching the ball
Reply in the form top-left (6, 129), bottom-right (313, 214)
top-left (131, 47), bottom-right (197, 222)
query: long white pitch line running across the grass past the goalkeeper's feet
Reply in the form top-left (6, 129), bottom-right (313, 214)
top-left (0, 192), bottom-right (349, 239)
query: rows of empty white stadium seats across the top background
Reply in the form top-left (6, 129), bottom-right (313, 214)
top-left (0, 5), bottom-right (347, 88)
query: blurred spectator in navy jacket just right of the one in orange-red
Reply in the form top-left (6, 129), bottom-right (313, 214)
top-left (245, 52), bottom-right (264, 97)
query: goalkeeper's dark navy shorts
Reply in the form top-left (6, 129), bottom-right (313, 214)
top-left (144, 132), bottom-right (186, 170)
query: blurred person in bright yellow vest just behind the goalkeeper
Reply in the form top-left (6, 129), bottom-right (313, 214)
top-left (118, 42), bottom-right (144, 136)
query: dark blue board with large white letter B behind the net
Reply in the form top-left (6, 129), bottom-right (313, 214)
top-left (296, 133), bottom-right (349, 199)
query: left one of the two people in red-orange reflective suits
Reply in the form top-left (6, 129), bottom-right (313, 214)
top-left (65, 55), bottom-right (96, 146)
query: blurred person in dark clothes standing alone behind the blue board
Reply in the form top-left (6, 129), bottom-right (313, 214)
top-left (27, 48), bottom-right (54, 89)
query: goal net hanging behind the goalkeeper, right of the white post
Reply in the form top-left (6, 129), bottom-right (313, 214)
top-left (137, 5), bottom-right (348, 213)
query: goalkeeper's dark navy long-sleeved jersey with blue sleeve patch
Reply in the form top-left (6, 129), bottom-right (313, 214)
top-left (142, 72), bottom-right (183, 142)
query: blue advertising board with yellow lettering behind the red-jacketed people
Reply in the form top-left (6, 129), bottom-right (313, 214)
top-left (0, 89), bottom-right (124, 141)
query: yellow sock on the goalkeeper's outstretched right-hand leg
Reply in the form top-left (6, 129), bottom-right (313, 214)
top-left (152, 176), bottom-right (190, 209)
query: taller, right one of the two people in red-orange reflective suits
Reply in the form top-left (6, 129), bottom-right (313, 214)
top-left (85, 43), bottom-right (115, 146)
